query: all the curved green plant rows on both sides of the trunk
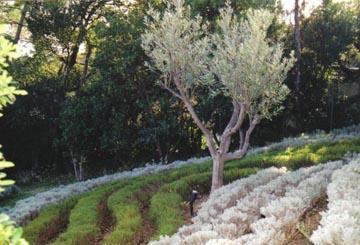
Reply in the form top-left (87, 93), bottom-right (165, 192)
top-left (24, 138), bottom-right (360, 244)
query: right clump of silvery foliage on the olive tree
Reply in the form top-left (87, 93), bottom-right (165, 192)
top-left (210, 4), bottom-right (295, 119)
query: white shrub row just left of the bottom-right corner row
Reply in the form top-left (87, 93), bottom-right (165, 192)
top-left (239, 161), bottom-right (341, 245)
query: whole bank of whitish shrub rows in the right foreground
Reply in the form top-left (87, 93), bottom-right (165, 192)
top-left (151, 155), bottom-right (360, 245)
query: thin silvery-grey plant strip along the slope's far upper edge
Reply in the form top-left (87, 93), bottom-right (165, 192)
top-left (6, 124), bottom-right (360, 224)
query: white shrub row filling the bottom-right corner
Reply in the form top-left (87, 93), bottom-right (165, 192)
top-left (310, 155), bottom-right (360, 245)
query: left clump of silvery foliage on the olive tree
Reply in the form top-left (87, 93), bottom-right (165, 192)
top-left (142, 0), bottom-right (210, 96)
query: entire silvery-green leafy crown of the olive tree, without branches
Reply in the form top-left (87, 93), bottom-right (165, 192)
top-left (142, 0), bottom-right (295, 121)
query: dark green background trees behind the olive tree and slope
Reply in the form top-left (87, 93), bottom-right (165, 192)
top-left (0, 0), bottom-right (360, 182)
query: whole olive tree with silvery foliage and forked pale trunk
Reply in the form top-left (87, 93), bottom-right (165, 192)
top-left (142, 0), bottom-right (294, 191)
